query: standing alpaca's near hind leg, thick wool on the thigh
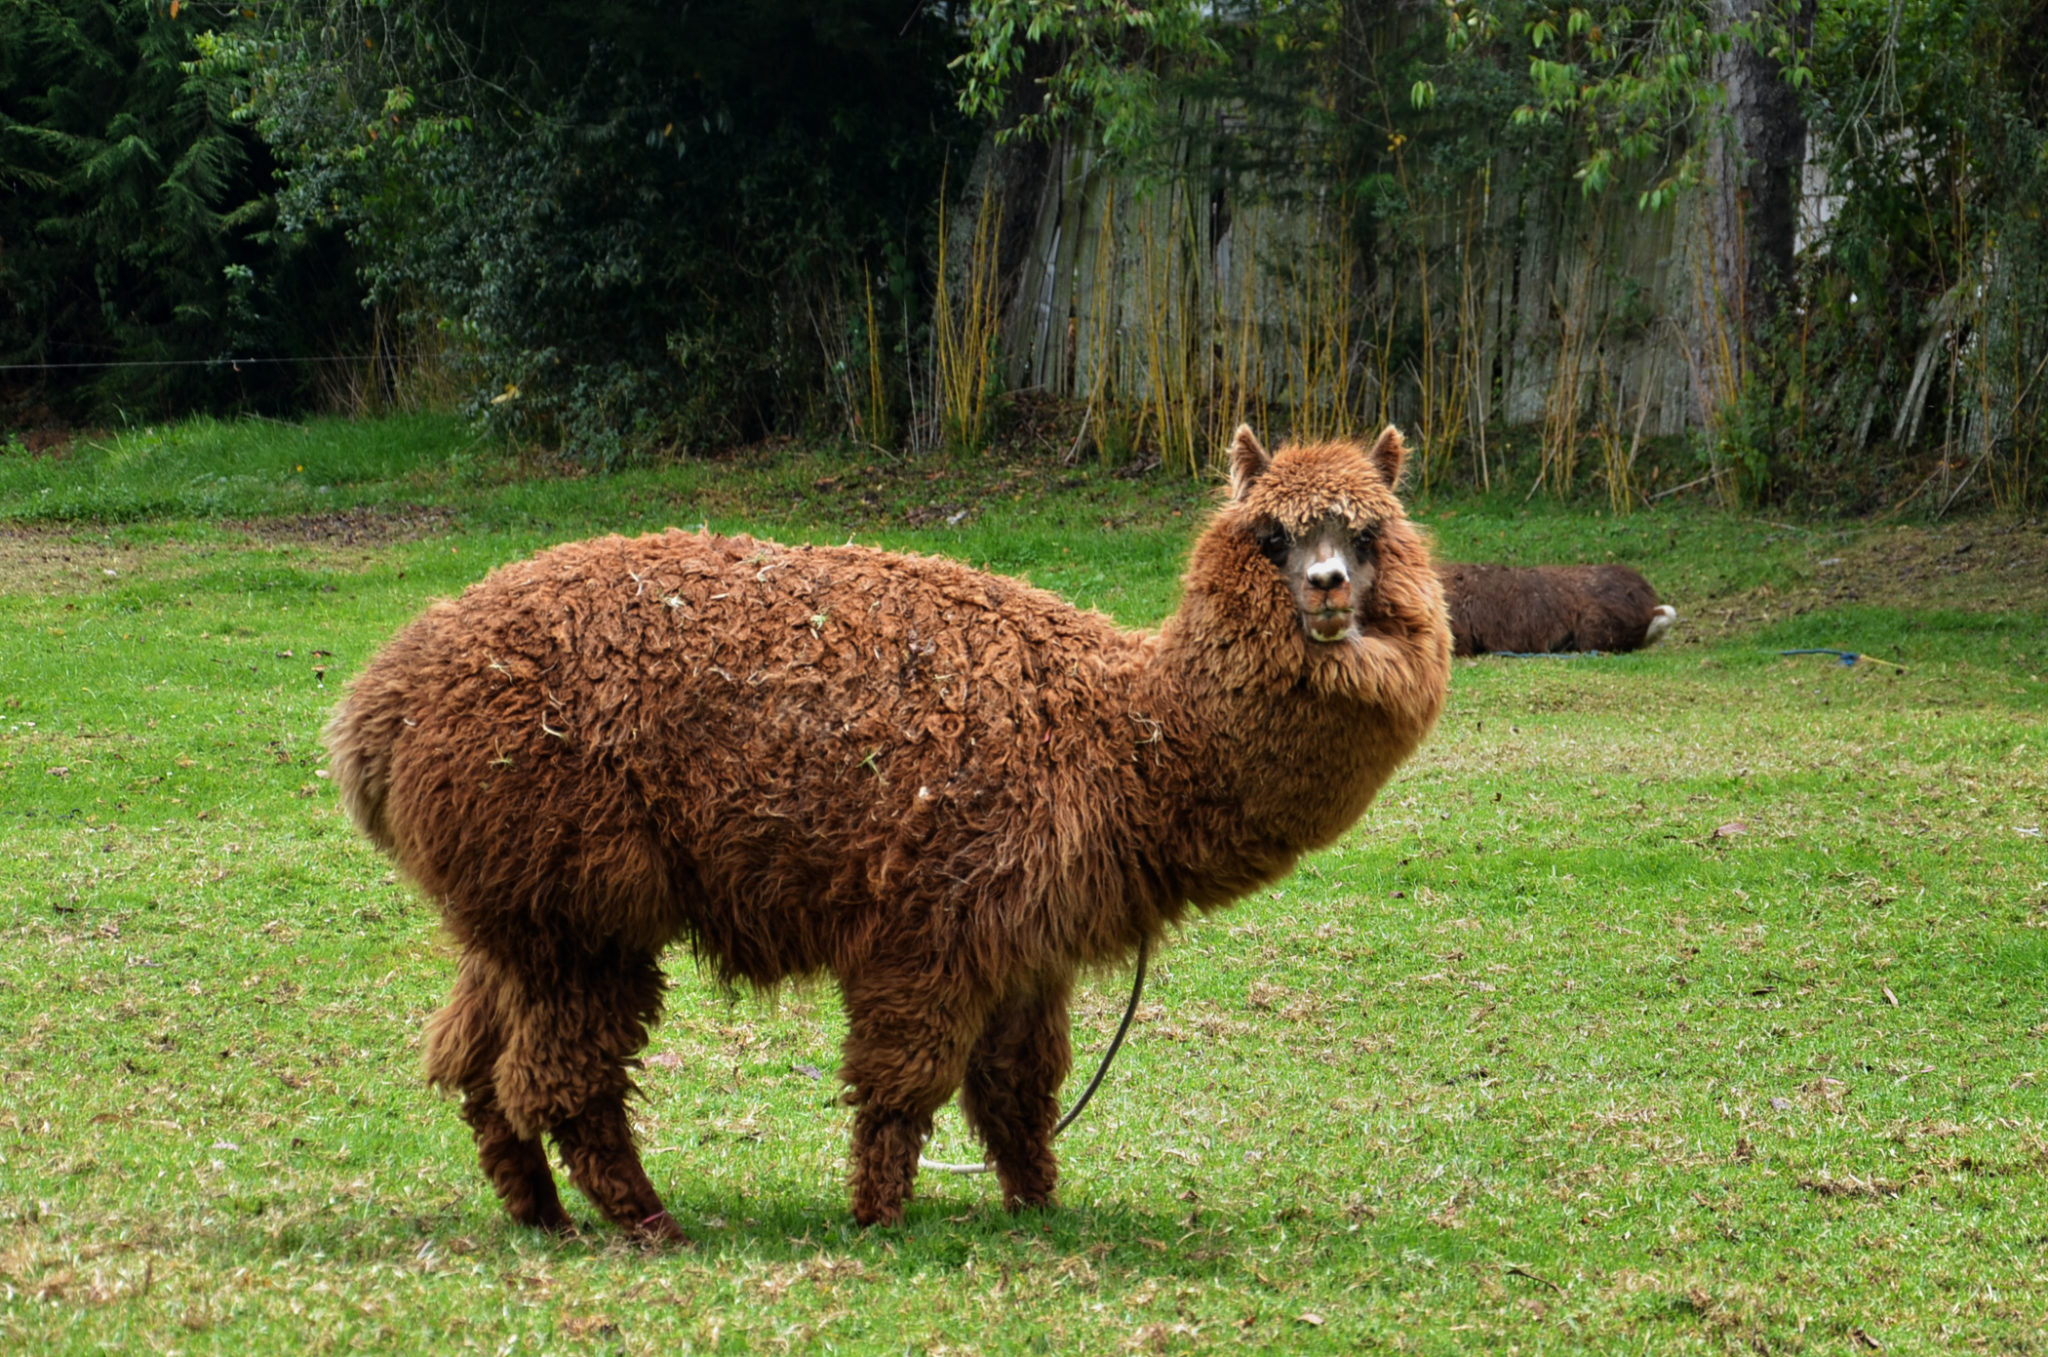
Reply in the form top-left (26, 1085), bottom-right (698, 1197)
top-left (496, 948), bottom-right (680, 1238)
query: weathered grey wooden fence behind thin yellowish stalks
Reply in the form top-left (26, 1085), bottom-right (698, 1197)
top-left (954, 111), bottom-right (1735, 497)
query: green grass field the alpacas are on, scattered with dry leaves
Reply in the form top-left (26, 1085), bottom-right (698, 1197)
top-left (0, 420), bottom-right (2048, 1357)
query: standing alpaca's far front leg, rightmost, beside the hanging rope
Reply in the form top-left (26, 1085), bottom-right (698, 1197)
top-left (961, 976), bottom-right (1073, 1210)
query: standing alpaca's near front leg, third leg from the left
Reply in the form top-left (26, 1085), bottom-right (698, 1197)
top-left (840, 978), bottom-right (981, 1226)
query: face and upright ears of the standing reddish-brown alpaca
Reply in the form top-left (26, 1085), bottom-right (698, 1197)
top-left (1223, 424), bottom-right (1413, 647)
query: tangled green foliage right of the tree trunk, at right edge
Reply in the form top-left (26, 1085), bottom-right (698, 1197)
top-left (1784, 0), bottom-right (2048, 508)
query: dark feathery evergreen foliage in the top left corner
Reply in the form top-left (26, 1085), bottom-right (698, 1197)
top-left (0, 0), bottom-right (360, 415)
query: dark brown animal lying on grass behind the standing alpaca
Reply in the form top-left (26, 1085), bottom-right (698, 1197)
top-left (1436, 563), bottom-right (1677, 655)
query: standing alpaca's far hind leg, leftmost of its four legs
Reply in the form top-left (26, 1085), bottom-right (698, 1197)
top-left (426, 952), bottom-right (573, 1232)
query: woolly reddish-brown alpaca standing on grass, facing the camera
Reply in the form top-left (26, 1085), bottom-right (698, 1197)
top-left (328, 428), bottom-right (1450, 1238)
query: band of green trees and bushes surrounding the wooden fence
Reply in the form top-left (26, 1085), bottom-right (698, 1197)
top-left (0, 0), bottom-right (2048, 508)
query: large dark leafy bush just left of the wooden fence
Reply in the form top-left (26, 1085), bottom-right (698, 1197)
top-left (240, 0), bottom-right (969, 463)
